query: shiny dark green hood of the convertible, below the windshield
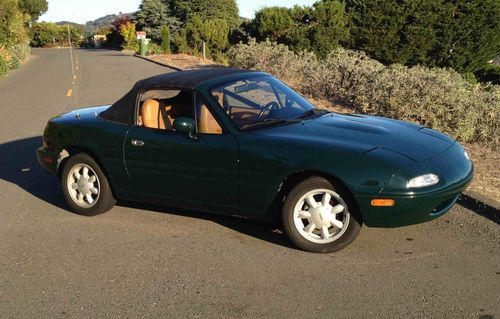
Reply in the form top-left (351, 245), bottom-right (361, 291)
top-left (253, 113), bottom-right (455, 162)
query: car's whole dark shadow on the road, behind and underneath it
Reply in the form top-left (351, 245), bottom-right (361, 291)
top-left (0, 136), bottom-right (293, 251)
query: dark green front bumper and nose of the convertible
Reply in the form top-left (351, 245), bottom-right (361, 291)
top-left (356, 143), bottom-right (474, 227)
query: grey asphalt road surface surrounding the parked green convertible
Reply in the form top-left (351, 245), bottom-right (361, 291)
top-left (0, 49), bottom-right (500, 319)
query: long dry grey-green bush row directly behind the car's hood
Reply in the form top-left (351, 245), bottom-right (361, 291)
top-left (229, 40), bottom-right (500, 148)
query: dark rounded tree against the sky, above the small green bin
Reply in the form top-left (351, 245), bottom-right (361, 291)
top-left (134, 0), bottom-right (180, 42)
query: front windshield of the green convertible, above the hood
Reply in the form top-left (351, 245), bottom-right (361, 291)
top-left (211, 76), bottom-right (315, 130)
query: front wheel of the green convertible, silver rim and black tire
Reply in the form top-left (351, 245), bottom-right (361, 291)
top-left (282, 177), bottom-right (362, 253)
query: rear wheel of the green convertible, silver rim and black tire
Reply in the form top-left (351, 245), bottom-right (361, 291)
top-left (61, 153), bottom-right (116, 216)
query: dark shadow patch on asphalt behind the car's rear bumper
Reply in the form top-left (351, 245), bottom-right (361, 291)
top-left (0, 136), bottom-right (67, 209)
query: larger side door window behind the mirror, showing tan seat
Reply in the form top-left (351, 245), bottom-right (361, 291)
top-left (137, 90), bottom-right (194, 131)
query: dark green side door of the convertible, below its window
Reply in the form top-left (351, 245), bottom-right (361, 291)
top-left (124, 90), bottom-right (239, 213)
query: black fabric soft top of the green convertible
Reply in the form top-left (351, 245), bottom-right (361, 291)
top-left (100, 68), bottom-right (251, 125)
